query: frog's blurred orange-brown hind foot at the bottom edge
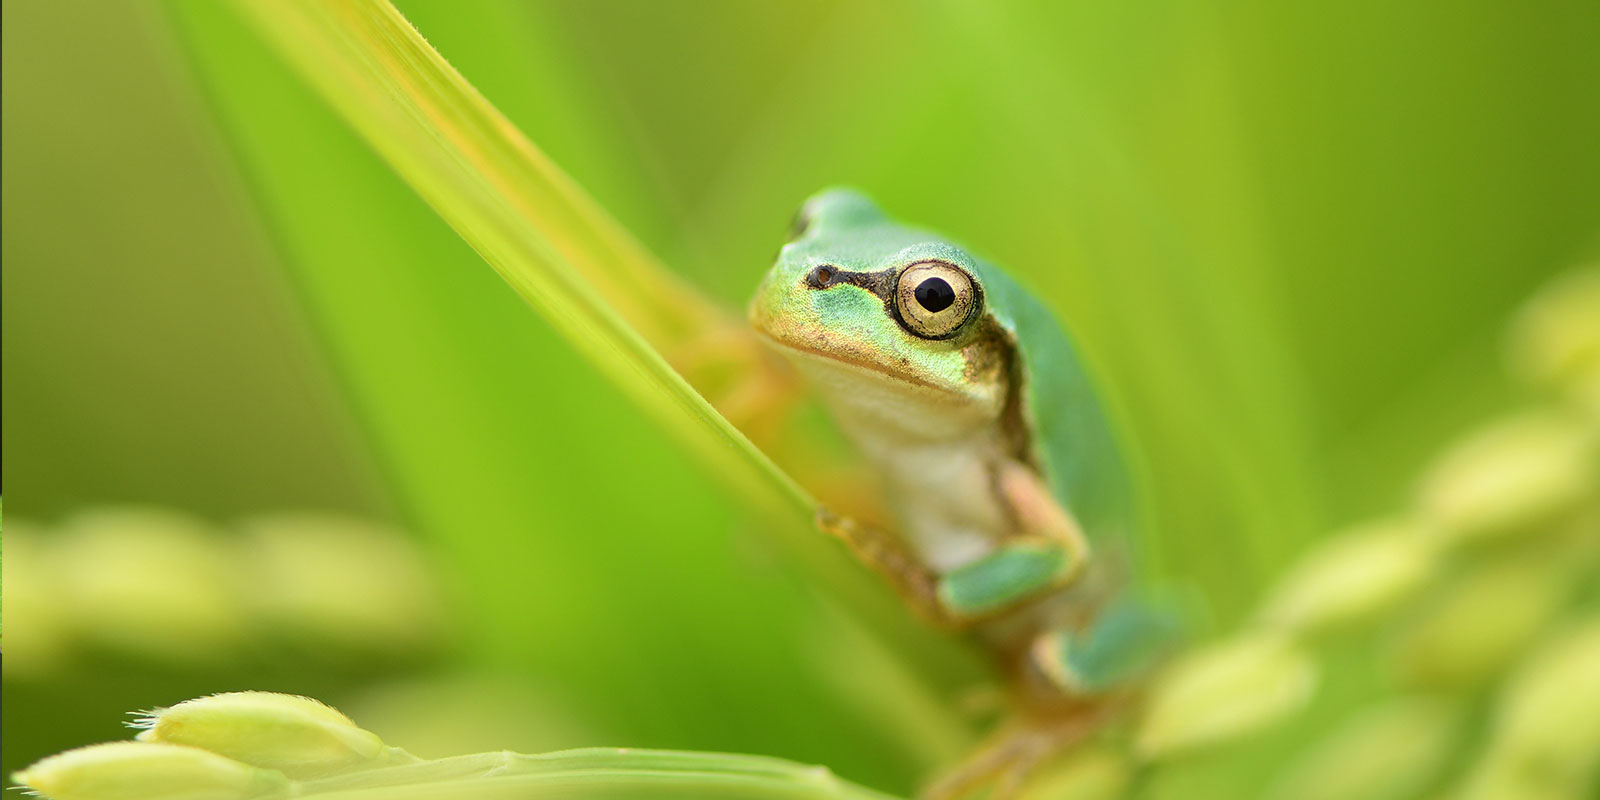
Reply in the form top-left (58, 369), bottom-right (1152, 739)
top-left (920, 702), bottom-right (1114, 800)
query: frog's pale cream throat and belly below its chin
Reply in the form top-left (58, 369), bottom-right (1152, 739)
top-left (774, 340), bottom-right (1013, 573)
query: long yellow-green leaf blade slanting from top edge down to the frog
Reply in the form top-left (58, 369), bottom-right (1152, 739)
top-left (235, 0), bottom-right (813, 517)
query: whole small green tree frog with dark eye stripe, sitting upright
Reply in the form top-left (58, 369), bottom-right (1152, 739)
top-left (750, 189), bottom-right (1173, 794)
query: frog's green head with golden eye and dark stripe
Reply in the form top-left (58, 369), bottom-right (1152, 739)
top-left (750, 189), bottom-right (1005, 428)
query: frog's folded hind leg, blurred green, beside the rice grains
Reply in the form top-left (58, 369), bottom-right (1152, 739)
top-left (1029, 597), bottom-right (1182, 696)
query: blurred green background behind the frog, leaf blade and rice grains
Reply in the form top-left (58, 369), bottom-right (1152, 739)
top-left (0, 0), bottom-right (1600, 792)
